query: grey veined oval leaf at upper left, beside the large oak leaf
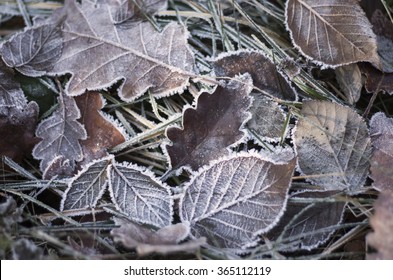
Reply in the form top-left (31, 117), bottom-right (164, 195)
top-left (0, 22), bottom-right (63, 77)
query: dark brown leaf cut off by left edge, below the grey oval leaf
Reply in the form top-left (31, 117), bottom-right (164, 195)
top-left (0, 59), bottom-right (38, 162)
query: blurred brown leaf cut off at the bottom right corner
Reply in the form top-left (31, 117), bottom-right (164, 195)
top-left (366, 191), bottom-right (393, 260)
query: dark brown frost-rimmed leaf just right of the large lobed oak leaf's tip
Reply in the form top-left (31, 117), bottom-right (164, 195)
top-left (213, 51), bottom-right (297, 100)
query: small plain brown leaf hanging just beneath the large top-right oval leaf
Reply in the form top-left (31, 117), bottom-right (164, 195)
top-left (335, 64), bottom-right (363, 105)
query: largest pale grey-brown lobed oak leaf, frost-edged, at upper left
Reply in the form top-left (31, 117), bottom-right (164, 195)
top-left (43, 0), bottom-right (195, 101)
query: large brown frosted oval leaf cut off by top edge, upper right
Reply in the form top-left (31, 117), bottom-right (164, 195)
top-left (285, 0), bottom-right (380, 67)
